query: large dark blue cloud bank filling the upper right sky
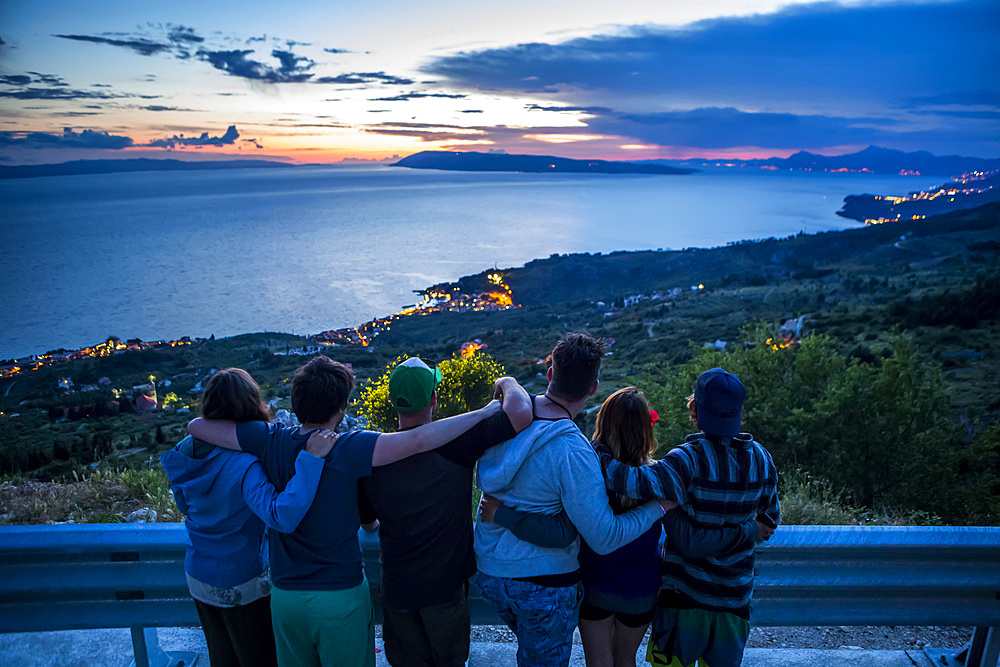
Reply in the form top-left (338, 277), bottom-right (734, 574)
top-left (425, 0), bottom-right (1000, 108)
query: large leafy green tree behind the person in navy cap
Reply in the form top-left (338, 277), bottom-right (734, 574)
top-left (639, 325), bottom-right (968, 516)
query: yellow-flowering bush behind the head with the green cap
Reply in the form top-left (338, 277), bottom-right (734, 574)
top-left (354, 352), bottom-right (504, 433)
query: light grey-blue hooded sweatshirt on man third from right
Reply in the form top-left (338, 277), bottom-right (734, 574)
top-left (476, 419), bottom-right (663, 578)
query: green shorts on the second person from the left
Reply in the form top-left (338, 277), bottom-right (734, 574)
top-left (271, 579), bottom-right (375, 667)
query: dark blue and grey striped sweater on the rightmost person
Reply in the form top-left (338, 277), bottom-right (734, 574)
top-left (601, 433), bottom-right (780, 618)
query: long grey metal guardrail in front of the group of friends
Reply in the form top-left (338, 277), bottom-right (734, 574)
top-left (0, 524), bottom-right (1000, 667)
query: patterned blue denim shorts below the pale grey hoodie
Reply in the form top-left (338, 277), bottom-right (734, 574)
top-left (476, 572), bottom-right (583, 667)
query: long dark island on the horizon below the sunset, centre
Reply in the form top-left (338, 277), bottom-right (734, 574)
top-left (391, 151), bottom-right (695, 174)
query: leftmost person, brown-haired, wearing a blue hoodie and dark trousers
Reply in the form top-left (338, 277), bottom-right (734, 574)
top-left (160, 368), bottom-right (333, 667)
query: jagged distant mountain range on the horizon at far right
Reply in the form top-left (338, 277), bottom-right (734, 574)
top-left (656, 146), bottom-right (1000, 176)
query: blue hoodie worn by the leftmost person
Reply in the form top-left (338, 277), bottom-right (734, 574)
top-left (160, 436), bottom-right (323, 588)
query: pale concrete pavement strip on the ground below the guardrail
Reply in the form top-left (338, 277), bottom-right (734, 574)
top-left (0, 628), bottom-right (933, 667)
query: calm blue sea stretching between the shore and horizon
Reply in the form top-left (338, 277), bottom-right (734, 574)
top-left (0, 167), bottom-right (930, 358)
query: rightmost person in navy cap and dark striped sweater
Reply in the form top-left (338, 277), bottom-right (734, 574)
top-left (598, 368), bottom-right (780, 667)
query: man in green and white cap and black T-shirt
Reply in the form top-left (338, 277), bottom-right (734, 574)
top-left (361, 357), bottom-right (575, 667)
